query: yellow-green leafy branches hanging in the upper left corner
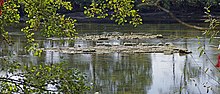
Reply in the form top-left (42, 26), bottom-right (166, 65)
top-left (0, 0), bottom-right (76, 55)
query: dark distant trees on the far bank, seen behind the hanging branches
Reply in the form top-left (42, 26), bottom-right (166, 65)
top-left (16, 0), bottom-right (220, 16)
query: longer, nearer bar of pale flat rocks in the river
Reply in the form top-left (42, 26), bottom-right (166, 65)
top-left (44, 43), bottom-right (192, 55)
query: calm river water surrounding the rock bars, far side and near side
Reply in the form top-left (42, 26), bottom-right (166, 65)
top-left (1, 24), bottom-right (220, 94)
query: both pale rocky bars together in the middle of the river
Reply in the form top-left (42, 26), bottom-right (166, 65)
top-left (43, 33), bottom-right (192, 55)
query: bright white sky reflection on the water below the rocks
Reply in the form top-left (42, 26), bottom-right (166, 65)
top-left (148, 54), bottom-right (177, 94)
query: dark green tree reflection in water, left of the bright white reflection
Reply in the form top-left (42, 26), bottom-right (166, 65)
top-left (88, 53), bottom-right (152, 94)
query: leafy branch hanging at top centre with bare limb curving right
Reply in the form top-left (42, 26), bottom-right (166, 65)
top-left (84, 0), bottom-right (218, 30)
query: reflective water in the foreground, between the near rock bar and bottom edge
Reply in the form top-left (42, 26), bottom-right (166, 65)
top-left (46, 39), bottom-right (220, 94)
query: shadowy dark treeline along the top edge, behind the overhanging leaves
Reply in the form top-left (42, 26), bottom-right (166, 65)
top-left (63, 0), bottom-right (220, 12)
